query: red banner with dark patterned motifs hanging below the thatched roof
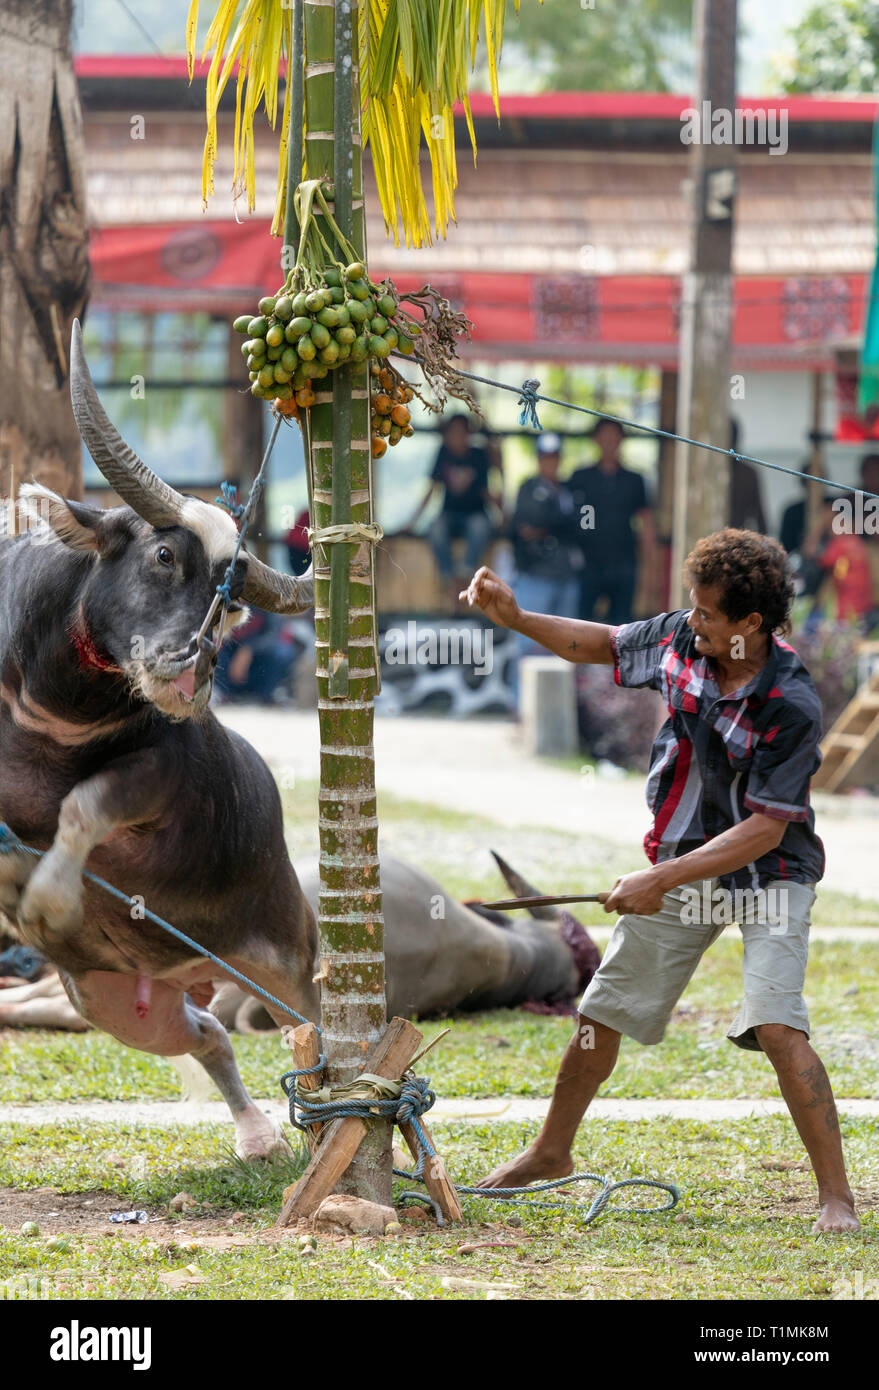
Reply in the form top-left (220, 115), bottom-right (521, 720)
top-left (90, 220), bottom-right (865, 370)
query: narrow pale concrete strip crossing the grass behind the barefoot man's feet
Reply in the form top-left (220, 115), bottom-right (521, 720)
top-left (0, 1097), bottom-right (879, 1125)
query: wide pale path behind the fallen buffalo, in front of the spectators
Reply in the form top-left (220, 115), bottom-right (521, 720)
top-left (218, 705), bottom-right (879, 898)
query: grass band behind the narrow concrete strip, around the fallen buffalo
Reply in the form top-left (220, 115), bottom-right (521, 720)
top-left (0, 930), bottom-right (879, 1102)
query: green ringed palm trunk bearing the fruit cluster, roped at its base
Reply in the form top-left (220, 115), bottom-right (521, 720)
top-left (300, 0), bottom-right (391, 1202)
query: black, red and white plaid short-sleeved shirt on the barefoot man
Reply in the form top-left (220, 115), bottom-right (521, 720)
top-left (611, 610), bottom-right (825, 888)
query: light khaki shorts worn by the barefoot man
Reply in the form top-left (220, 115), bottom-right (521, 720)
top-left (580, 878), bottom-right (815, 1052)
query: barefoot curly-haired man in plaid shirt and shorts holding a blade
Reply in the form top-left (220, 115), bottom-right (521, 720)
top-left (466, 530), bottom-right (860, 1232)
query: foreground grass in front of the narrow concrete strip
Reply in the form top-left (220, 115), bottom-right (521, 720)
top-left (0, 1118), bottom-right (879, 1300)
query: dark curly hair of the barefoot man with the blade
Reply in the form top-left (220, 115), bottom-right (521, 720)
top-left (684, 527), bottom-right (794, 632)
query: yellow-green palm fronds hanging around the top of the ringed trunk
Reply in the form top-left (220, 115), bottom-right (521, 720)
top-left (186, 0), bottom-right (525, 246)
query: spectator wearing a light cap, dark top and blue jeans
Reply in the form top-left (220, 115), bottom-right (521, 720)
top-left (512, 432), bottom-right (581, 692)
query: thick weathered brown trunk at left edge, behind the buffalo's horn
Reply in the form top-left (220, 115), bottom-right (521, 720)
top-left (0, 0), bottom-right (89, 498)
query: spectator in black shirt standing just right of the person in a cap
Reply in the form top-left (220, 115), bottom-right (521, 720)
top-left (567, 420), bottom-right (655, 626)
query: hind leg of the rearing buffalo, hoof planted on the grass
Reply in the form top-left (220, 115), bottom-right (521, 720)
top-left (64, 970), bottom-right (289, 1158)
